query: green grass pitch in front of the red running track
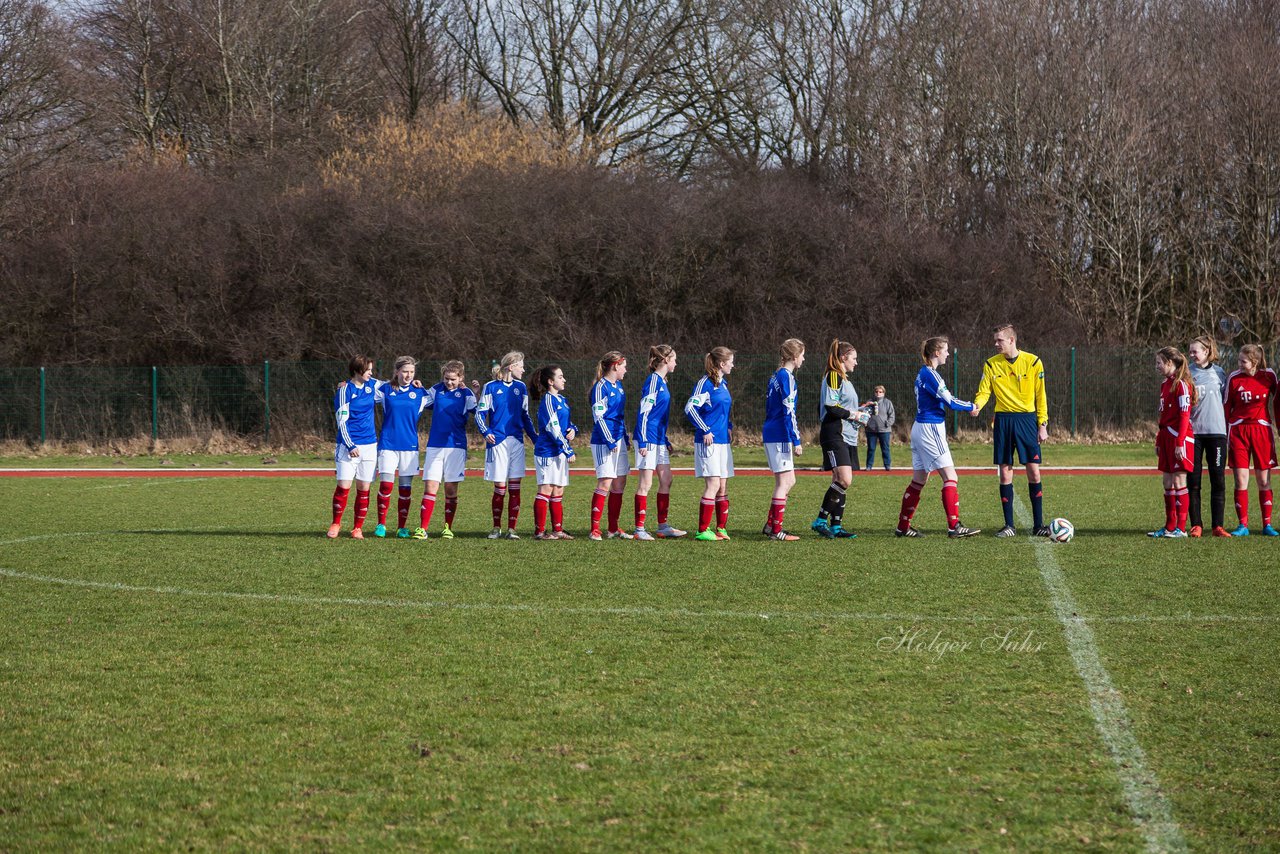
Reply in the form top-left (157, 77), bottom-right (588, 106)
top-left (0, 471), bottom-right (1280, 850)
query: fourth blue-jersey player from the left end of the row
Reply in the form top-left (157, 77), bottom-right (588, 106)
top-left (476, 351), bottom-right (538, 540)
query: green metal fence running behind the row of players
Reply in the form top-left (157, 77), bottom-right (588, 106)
top-left (0, 348), bottom-right (1274, 443)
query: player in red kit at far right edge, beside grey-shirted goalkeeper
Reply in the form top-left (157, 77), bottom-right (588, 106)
top-left (1224, 344), bottom-right (1280, 536)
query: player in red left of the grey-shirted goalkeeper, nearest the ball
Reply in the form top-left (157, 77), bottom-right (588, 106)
top-left (1147, 347), bottom-right (1196, 536)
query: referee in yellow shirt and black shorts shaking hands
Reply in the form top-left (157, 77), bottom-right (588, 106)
top-left (973, 324), bottom-right (1048, 536)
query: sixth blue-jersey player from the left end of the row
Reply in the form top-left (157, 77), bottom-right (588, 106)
top-left (589, 350), bottom-right (629, 540)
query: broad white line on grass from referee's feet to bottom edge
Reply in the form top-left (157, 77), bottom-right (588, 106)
top-left (1014, 495), bottom-right (1187, 851)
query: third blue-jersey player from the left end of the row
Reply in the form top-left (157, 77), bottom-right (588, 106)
top-left (413, 359), bottom-right (480, 540)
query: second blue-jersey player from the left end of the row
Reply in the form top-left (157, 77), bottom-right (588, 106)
top-left (374, 356), bottom-right (426, 538)
